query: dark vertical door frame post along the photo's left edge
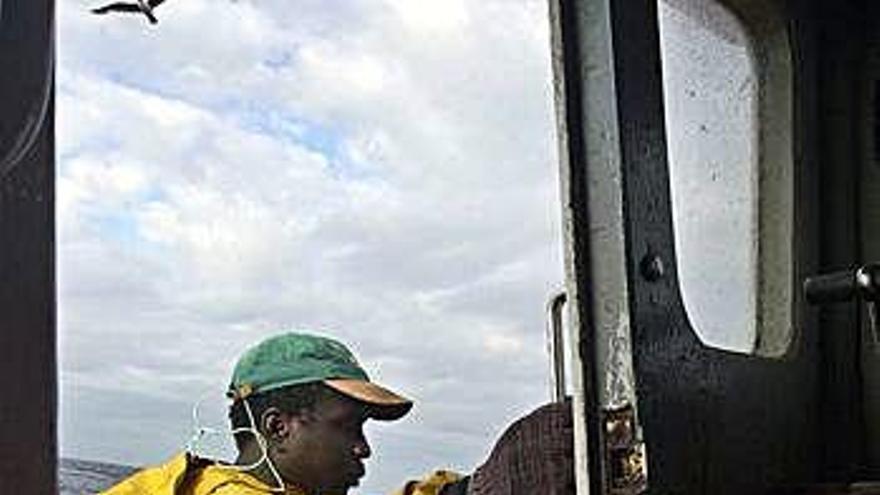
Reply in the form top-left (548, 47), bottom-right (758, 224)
top-left (0, 0), bottom-right (57, 494)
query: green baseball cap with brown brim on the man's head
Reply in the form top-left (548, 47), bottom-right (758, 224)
top-left (228, 332), bottom-right (412, 420)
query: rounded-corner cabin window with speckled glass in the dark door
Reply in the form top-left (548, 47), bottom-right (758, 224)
top-left (658, 0), bottom-right (792, 354)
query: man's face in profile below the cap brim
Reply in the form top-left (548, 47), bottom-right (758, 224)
top-left (273, 392), bottom-right (370, 495)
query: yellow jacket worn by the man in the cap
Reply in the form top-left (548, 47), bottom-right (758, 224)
top-left (102, 453), bottom-right (461, 495)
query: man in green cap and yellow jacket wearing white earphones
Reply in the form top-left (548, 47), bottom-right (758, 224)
top-left (104, 333), bottom-right (460, 495)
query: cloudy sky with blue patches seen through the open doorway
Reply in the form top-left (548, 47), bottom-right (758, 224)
top-left (57, 0), bottom-right (562, 494)
